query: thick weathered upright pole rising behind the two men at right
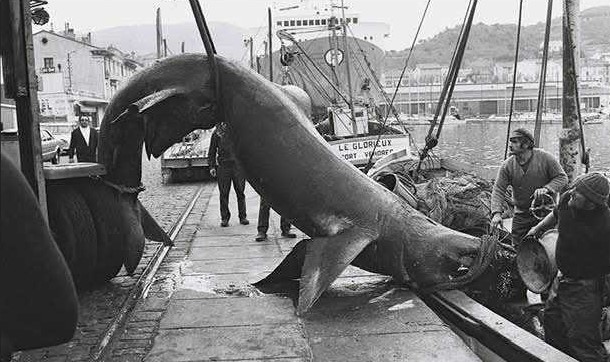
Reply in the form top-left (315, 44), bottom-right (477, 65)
top-left (559, 0), bottom-right (583, 181)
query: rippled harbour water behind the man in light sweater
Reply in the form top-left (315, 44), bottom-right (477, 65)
top-left (409, 121), bottom-right (610, 177)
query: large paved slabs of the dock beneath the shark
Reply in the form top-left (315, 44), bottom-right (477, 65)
top-left (138, 186), bottom-right (478, 362)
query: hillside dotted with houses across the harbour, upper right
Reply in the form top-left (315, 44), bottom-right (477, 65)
top-left (386, 6), bottom-right (610, 69)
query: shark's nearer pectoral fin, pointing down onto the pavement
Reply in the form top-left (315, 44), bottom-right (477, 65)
top-left (297, 227), bottom-right (376, 315)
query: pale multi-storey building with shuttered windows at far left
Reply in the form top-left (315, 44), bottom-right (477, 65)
top-left (33, 23), bottom-right (142, 127)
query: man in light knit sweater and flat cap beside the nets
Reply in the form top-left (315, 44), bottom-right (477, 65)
top-left (491, 128), bottom-right (568, 246)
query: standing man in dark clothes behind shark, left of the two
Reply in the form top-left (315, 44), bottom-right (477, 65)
top-left (208, 122), bottom-right (250, 227)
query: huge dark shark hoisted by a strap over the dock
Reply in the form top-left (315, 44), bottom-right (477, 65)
top-left (100, 54), bottom-right (492, 314)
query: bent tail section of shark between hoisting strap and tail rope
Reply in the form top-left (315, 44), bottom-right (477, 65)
top-left (98, 54), bottom-right (220, 187)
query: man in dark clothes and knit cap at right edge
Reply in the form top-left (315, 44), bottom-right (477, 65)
top-left (527, 172), bottom-right (610, 361)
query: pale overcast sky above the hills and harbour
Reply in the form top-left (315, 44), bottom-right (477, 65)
top-left (34, 0), bottom-right (610, 50)
